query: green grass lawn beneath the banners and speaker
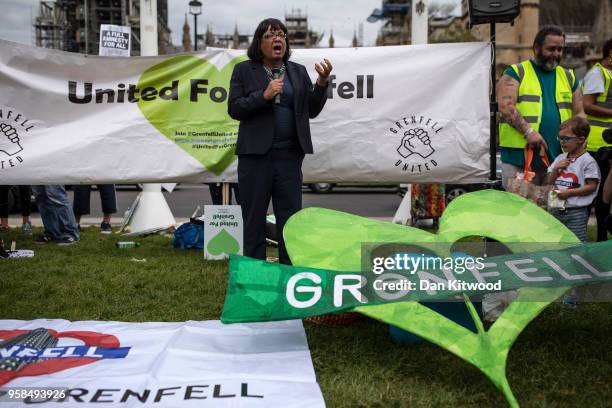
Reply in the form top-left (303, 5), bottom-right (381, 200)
top-left (0, 228), bottom-right (612, 408)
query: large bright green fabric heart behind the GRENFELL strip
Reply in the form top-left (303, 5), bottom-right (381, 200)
top-left (283, 190), bottom-right (579, 407)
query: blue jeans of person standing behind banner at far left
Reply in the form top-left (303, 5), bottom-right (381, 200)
top-left (33, 185), bottom-right (79, 240)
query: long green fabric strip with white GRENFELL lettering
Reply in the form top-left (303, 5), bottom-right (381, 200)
top-left (221, 242), bottom-right (612, 323)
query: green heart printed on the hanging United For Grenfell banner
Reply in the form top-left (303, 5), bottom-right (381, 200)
top-left (137, 55), bottom-right (247, 176)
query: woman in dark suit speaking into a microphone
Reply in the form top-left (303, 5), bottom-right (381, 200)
top-left (228, 18), bottom-right (332, 264)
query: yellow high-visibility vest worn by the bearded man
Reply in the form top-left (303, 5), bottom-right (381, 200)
top-left (499, 60), bottom-right (576, 149)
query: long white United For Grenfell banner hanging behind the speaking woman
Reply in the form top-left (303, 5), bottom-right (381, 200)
top-left (0, 41), bottom-right (490, 184)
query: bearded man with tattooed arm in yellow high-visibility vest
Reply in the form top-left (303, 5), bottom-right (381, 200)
top-left (497, 26), bottom-right (584, 188)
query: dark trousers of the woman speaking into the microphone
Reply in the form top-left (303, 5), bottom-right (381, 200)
top-left (238, 149), bottom-right (304, 265)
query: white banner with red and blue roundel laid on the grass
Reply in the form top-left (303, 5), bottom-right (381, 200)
top-left (0, 319), bottom-right (325, 408)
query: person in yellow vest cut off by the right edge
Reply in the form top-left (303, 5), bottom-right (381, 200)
top-left (584, 39), bottom-right (612, 241)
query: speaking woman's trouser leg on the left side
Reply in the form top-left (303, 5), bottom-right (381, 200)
top-left (238, 153), bottom-right (273, 260)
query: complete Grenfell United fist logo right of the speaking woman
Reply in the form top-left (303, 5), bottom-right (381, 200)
top-left (389, 115), bottom-right (444, 173)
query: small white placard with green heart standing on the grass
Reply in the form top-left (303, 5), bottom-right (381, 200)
top-left (204, 205), bottom-right (243, 259)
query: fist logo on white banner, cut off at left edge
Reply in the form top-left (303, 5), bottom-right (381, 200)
top-left (0, 107), bottom-right (34, 170)
